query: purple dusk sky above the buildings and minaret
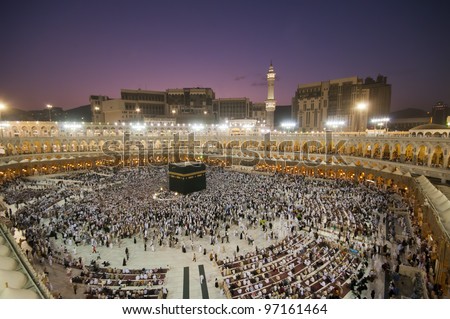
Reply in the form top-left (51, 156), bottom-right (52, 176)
top-left (0, 0), bottom-right (450, 110)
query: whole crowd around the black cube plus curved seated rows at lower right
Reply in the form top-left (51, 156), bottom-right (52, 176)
top-left (2, 167), bottom-right (440, 298)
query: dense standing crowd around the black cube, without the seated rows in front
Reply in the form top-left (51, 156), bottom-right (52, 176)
top-left (2, 167), bottom-right (428, 297)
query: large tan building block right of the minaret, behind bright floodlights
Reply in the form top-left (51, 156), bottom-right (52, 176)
top-left (292, 76), bottom-right (391, 131)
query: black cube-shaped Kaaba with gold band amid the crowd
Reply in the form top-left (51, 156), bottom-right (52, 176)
top-left (169, 162), bottom-right (206, 195)
